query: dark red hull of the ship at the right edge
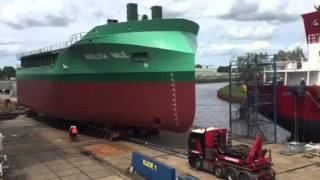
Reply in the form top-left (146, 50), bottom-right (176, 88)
top-left (251, 85), bottom-right (320, 142)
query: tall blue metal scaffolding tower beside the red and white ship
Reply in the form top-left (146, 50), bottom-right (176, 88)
top-left (229, 56), bottom-right (277, 142)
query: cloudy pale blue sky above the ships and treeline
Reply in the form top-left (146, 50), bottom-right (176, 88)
top-left (0, 0), bottom-right (319, 67)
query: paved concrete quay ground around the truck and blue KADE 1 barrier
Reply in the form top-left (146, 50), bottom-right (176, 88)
top-left (0, 116), bottom-right (320, 180)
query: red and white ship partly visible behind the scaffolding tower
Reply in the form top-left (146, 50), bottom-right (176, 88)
top-left (260, 8), bottom-right (320, 142)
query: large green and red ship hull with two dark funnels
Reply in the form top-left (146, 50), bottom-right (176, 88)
top-left (17, 3), bottom-right (199, 132)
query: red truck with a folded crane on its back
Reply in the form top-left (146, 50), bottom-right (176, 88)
top-left (188, 127), bottom-right (275, 180)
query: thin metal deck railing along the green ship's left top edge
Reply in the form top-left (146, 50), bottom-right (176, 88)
top-left (17, 32), bottom-right (87, 59)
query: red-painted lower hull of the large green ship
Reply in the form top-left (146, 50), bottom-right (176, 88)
top-left (17, 80), bottom-right (195, 132)
